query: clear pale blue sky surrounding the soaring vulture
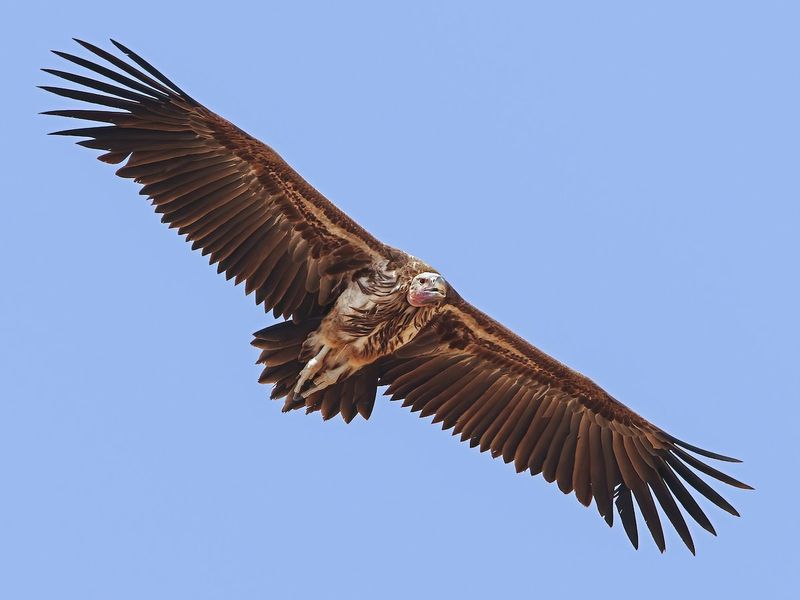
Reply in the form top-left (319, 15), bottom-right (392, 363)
top-left (0, 1), bottom-right (800, 600)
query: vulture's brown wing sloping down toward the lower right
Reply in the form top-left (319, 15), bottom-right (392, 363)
top-left (380, 298), bottom-right (751, 553)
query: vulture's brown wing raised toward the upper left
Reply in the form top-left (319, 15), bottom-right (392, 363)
top-left (42, 40), bottom-right (396, 319)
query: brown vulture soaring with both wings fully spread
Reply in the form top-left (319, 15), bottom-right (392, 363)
top-left (41, 40), bottom-right (752, 554)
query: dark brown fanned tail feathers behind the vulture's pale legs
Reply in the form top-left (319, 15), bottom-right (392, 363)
top-left (251, 319), bottom-right (378, 423)
